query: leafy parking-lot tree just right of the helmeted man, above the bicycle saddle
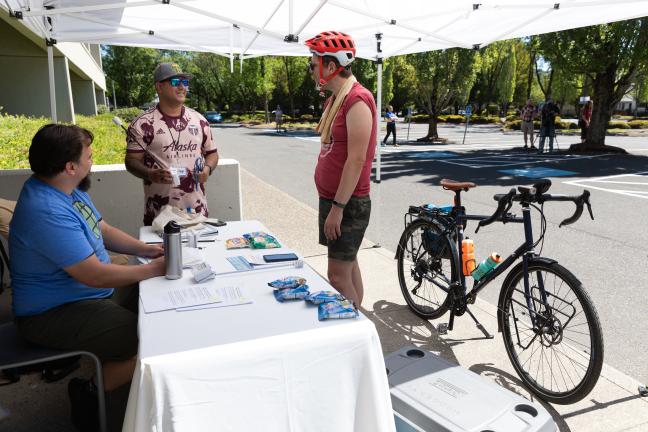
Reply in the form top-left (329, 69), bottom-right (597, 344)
top-left (407, 48), bottom-right (477, 141)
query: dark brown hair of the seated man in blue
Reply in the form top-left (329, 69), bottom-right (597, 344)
top-left (29, 124), bottom-right (94, 178)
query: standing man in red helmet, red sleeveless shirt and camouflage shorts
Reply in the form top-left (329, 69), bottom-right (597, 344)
top-left (305, 31), bottom-right (377, 306)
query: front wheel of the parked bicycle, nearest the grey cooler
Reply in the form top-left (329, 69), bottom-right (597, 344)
top-left (501, 261), bottom-right (603, 404)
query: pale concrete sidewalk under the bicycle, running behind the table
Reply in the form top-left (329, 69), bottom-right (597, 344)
top-left (241, 170), bottom-right (648, 432)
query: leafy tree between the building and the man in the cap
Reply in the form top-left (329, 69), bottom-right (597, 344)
top-left (103, 45), bottom-right (160, 106)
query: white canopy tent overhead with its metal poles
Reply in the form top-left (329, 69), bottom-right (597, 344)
top-left (0, 0), bottom-right (648, 181)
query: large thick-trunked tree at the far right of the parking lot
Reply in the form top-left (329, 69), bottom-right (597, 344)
top-left (538, 18), bottom-right (648, 151)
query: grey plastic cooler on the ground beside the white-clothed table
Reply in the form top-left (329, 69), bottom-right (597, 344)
top-left (385, 346), bottom-right (556, 432)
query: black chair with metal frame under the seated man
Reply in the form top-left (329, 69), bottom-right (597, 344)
top-left (0, 226), bottom-right (108, 432)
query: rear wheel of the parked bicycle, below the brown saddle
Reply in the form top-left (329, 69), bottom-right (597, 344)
top-left (396, 219), bottom-right (459, 319)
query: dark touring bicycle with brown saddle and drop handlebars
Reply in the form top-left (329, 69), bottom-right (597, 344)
top-left (395, 179), bottom-right (603, 404)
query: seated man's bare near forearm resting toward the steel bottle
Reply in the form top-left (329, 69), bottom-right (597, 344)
top-left (64, 254), bottom-right (165, 288)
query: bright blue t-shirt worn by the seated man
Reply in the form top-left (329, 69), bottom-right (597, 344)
top-left (9, 177), bottom-right (113, 316)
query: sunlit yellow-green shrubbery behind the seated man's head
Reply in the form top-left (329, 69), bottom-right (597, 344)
top-left (0, 113), bottom-right (126, 169)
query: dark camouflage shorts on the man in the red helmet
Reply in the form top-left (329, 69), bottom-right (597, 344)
top-left (319, 196), bottom-right (371, 261)
